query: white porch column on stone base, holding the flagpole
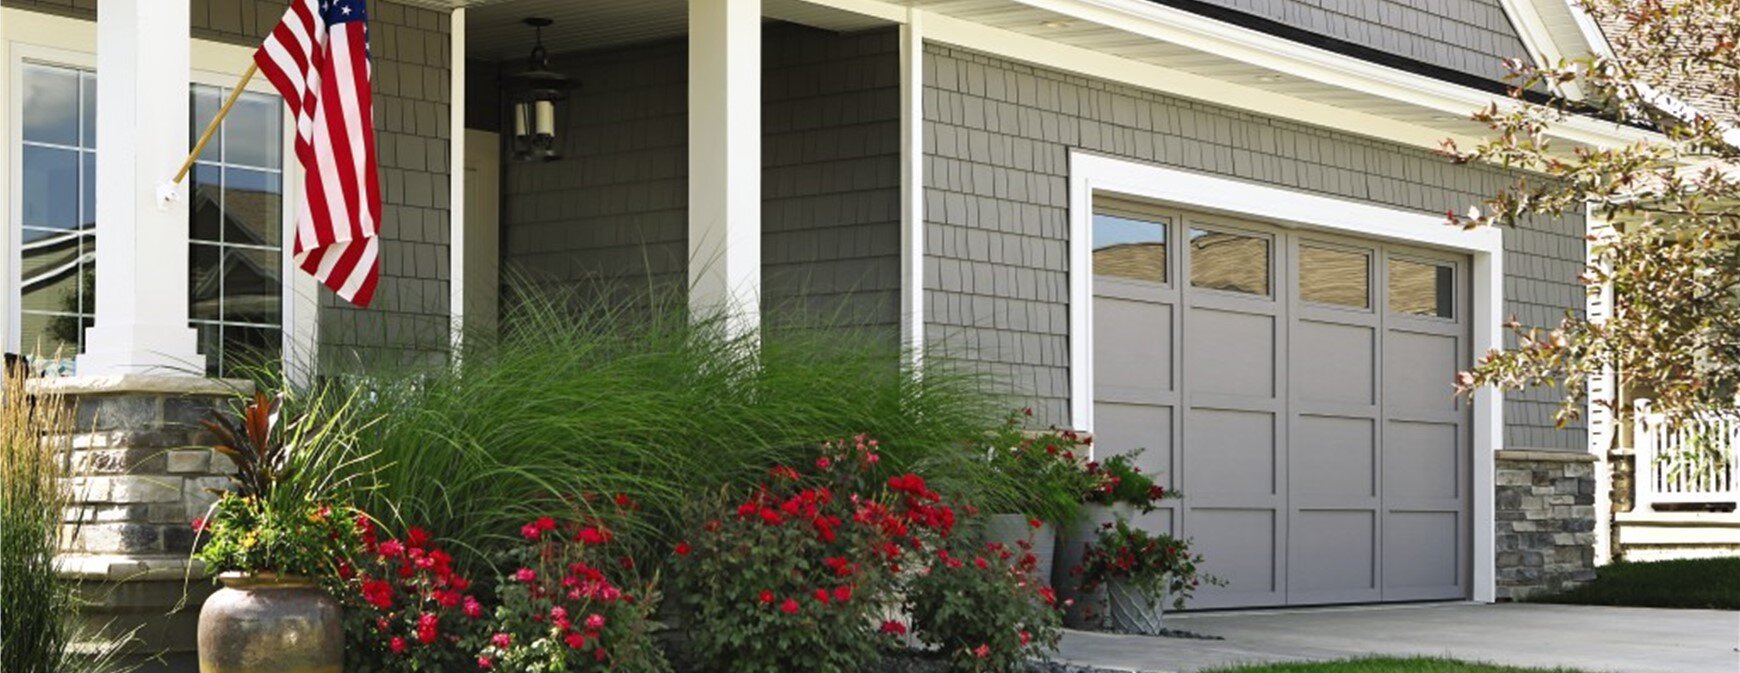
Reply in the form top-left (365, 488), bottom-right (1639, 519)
top-left (78, 0), bottom-right (205, 376)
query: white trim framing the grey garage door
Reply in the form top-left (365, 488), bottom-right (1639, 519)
top-left (1070, 151), bottom-right (1505, 602)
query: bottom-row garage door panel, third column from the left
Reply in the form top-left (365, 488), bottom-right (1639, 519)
top-left (1288, 510), bottom-right (1380, 603)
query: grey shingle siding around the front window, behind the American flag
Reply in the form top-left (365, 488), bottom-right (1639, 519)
top-left (3, 0), bottom-right (451, 365)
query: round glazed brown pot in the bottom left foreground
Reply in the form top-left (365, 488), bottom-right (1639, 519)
top-left (198, 572), bottom-right (345, 673)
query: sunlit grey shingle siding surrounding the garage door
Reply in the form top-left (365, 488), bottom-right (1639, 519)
top-left (924, 45), bottom-right (1583, 450)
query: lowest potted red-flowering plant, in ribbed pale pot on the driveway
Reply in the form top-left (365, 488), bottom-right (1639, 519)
top-left (1077, 518), bottom-right (1221, 635)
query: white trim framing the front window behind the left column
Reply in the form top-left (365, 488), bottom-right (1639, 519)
top-left (0, 9), bottom-right (320, 381)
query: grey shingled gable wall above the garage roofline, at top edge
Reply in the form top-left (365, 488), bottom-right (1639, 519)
top-left (1176, 0), bottom-right (1529, 82)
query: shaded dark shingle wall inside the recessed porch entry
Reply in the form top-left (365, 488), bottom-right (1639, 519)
top-left (503, 24), bottom-right (900, 334)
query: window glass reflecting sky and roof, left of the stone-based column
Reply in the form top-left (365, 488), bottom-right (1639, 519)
top-left (17, 64), bottom-right (97, 374)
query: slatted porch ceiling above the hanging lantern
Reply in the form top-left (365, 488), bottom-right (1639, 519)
top-left (459, 0), bottom-right (889, 61)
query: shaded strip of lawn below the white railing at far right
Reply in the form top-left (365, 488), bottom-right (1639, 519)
top-left (1529, 558), bottom-right (1740, 610)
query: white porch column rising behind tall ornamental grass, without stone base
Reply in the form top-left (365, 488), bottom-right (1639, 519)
top-left (689, 0), bottom-right (762, 334)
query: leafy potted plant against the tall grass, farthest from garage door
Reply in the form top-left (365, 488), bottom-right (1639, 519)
top-left (985, 410), bottom-right (1093, 584)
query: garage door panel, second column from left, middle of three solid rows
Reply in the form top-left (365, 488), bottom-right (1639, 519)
top-left (1180, 409), bottom-right (1281, 497)
